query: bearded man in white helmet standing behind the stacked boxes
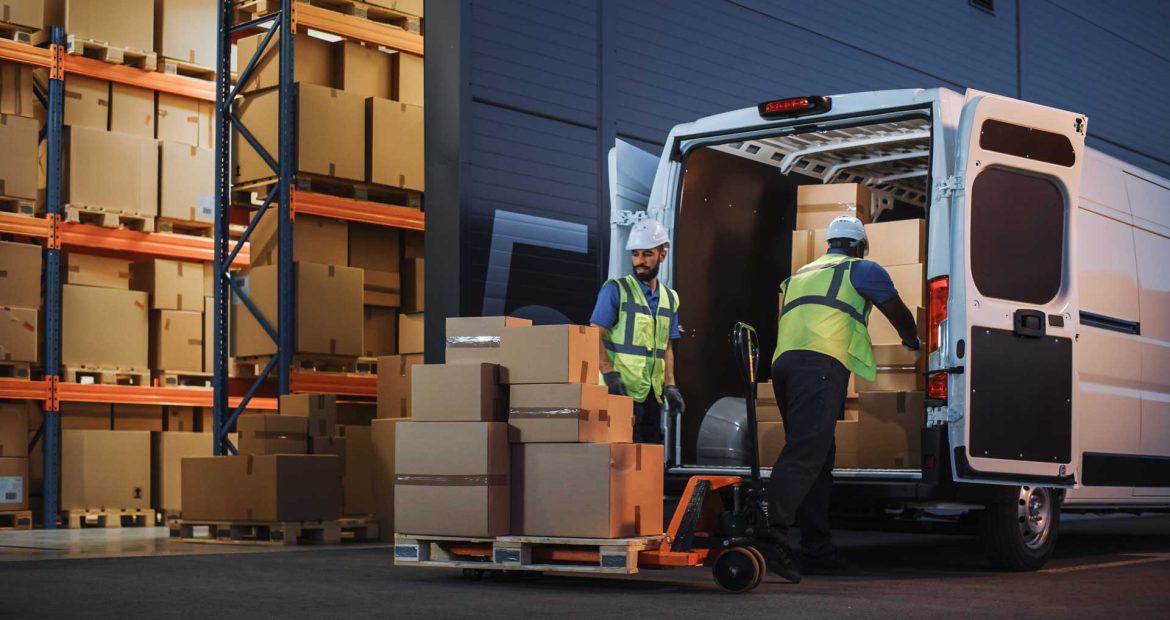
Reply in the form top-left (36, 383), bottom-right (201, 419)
top-left (590, 220), bottom-right (687, 443)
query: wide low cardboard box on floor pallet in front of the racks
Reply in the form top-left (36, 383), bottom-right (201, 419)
top-left (183, 454), bottom-right (342, 522)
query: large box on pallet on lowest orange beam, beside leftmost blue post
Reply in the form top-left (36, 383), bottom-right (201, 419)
top-left (61, 284), bottom-right (150, 370)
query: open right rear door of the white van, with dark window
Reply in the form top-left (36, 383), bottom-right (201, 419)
top-left (950, 90), bottom-right (1087, 487)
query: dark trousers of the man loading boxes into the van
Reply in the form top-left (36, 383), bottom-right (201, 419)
top-left (768, 351), bottom-right (849, 554)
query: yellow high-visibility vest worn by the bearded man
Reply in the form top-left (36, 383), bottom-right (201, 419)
top-left (604, 276), bottom-right (679, 404)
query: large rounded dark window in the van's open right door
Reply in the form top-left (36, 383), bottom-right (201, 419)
top-left (971, 167), bottom-right (1066, 304)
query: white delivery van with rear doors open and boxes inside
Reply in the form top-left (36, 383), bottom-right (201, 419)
top-left (610, 89), bottom-right (1170, 570)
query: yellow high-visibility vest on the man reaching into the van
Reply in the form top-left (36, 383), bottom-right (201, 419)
top-left (772, 254), bottom-right (875, 380)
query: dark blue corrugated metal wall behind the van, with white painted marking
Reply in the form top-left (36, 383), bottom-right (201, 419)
top-left (461, 0), bottom-right (1170, 322)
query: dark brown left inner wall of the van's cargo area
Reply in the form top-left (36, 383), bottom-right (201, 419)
top-left (673, 149), bottom-right (815, 462)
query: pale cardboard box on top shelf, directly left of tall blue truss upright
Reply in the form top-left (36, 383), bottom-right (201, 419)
top-left (154, 0), bottom-right (218, 69)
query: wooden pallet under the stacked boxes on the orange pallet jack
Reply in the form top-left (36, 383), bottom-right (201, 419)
top-left (394, 533), bottom-right (662, 574)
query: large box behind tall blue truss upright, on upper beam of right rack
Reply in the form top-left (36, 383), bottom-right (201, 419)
top-left (235, 83), bottom-right (365, 182)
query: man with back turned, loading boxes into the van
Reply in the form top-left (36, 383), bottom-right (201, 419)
top-left (768, 215), bottom-right (921, 581)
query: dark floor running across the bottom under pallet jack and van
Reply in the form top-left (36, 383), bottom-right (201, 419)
top-left (0, 516), bottom-right (1170, 619)
